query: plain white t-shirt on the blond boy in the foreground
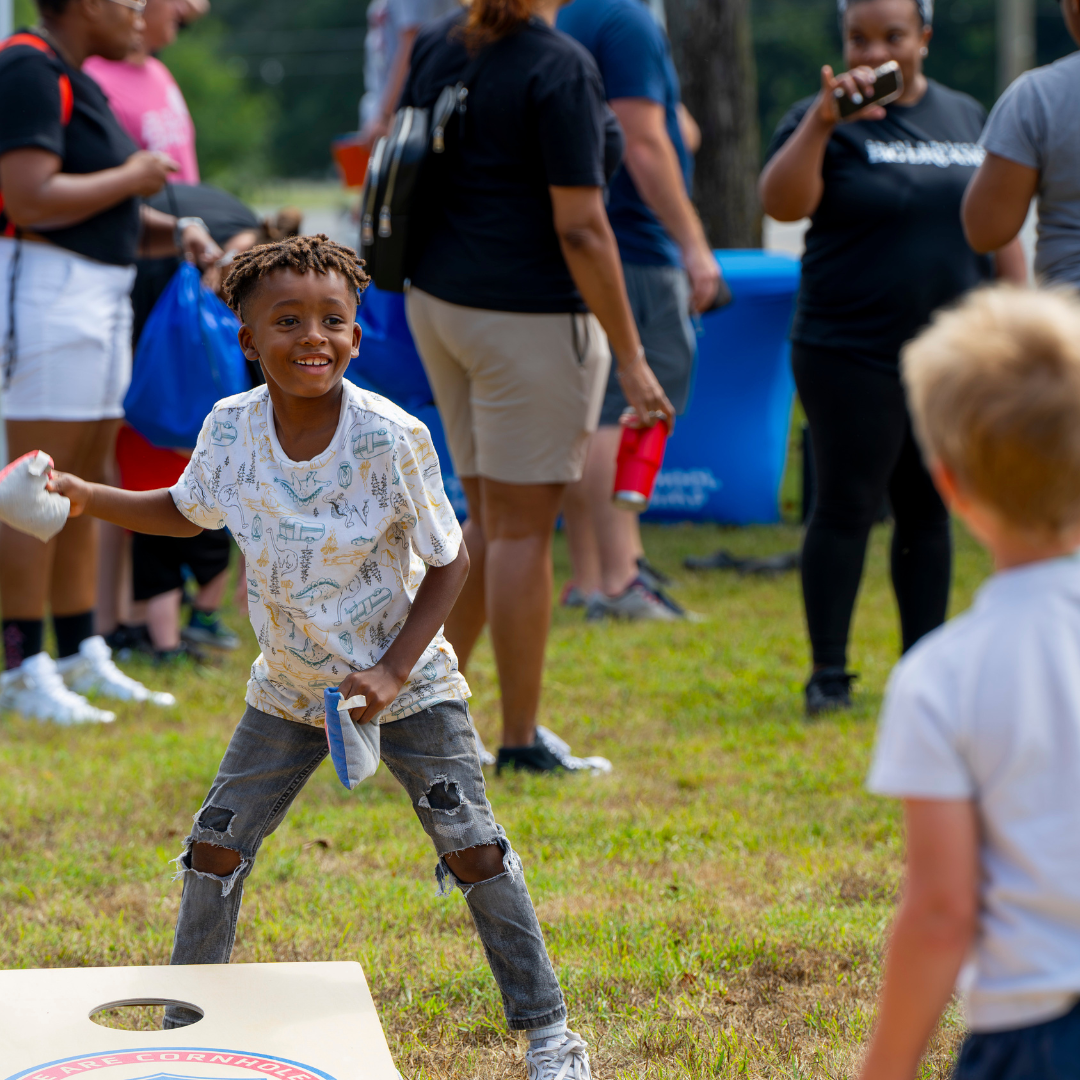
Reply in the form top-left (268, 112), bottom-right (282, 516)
top-left (868, 556), bottom-right (1080, 1031)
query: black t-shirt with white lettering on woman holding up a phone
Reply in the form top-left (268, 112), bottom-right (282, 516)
top-left (768, 80), bottom-right (993, 365)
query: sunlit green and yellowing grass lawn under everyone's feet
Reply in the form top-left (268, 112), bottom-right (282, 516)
top-left (0, 526), bottom-right (988, 1080)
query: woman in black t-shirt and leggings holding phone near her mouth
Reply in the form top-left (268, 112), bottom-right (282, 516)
top-left (759, 0), bottom-right (1026, 715)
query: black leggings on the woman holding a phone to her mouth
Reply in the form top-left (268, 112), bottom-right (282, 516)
top-left (792, 345), bottom-right (953, 667)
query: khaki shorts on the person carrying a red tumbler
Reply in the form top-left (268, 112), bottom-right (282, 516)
top-left (405, 287), bottom-right (611, 484)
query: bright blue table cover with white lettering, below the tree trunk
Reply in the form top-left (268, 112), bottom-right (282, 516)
top-left (645, 251), bottom-right (800, 525)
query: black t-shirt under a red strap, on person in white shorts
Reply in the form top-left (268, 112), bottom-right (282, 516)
top-left (0, 30), bottom-right (140, 266)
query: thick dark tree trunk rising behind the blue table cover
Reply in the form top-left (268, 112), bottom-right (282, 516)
top-left (666, 0), bottom-right (761, 247)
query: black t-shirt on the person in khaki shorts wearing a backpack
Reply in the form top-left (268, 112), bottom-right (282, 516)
top-left (401, 13), bottom-right (619, 312)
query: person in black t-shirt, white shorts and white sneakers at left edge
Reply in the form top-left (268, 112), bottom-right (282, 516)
top-left (0, 0), bottom-right (221, 724)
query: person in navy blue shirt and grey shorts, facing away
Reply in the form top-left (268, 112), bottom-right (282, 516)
top-left (556, 0), bottom-right (719, 619)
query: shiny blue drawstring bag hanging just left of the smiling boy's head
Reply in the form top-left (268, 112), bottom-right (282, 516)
top-left (124, 261), bottom-right (252, 448)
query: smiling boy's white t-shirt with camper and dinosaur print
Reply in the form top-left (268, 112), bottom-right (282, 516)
top-left (171, 380), bottom-right (469, 726)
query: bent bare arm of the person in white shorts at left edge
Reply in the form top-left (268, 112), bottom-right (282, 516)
top-left (0, 147), bottom-right (177, 229)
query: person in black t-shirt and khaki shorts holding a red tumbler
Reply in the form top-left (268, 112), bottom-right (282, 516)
top-left (402, 0), bottom-right (673, 771)
